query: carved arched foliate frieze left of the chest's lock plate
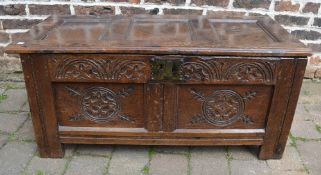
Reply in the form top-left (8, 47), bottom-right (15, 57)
top-left (54, 59), bottom-right (148, 81)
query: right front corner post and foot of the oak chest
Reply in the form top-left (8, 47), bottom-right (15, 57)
top-left (259, 59), bottom-right (307, 159)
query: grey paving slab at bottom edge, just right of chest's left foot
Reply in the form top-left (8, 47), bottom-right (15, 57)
top-left (65, 156), bottom-right (109, 175)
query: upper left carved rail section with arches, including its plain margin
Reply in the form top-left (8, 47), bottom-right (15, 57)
top-left (49, 54), bottom-right (150, 82)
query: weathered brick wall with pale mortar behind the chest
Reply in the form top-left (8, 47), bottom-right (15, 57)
top-left (0, 0), bottom-right (321, 78)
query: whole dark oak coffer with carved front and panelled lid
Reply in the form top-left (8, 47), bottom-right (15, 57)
top-left (7, 15), bottom-right (310, 159)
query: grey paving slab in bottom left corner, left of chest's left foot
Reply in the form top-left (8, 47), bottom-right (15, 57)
top-left (0, 141), bottom-right (36, 175)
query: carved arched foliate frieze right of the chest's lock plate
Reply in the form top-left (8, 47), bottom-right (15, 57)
top-left (180, 59), bottom-right (275, 82)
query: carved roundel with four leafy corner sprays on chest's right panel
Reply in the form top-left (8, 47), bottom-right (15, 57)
top-left (190, 88), bottom-right (256, 126)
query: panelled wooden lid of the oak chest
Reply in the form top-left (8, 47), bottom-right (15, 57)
top-left (6, 15), bottom-right (310, 56)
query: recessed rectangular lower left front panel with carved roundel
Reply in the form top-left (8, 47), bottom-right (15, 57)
top-left (54, 83), bottom-right (144, 128)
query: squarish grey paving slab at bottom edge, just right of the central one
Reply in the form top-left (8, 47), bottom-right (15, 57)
top-left (190, 147), bottom-right (228, 175)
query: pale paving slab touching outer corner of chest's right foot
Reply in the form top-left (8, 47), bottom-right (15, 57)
top-left (267, 146), bottom-right (305, 173)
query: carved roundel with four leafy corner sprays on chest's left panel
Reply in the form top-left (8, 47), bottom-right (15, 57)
top-left (65, 86), bottom-right (134, 122)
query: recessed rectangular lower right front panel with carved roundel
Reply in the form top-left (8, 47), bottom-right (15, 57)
top-left (177, 85), bottom-right (272, 129)
